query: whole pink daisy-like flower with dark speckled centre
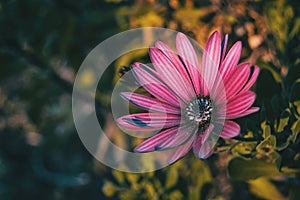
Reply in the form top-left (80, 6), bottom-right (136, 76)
top-left (117, 32), bottom-right (259, 163)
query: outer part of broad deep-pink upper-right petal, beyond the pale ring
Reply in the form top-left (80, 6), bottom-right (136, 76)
top-left (224, 63), bottom-right (250, 101)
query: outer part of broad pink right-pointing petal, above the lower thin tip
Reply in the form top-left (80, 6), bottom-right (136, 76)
top-left (226, 91), bottom-right (256, 119)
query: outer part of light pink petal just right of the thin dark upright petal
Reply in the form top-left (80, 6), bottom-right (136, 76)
top-left (219, 42), bottom-right (242, 80)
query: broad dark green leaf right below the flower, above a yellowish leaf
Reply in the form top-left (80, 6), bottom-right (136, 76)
top-left (228, 157), bottom-right (283, 181)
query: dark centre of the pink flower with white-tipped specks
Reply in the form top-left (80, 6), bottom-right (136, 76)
top-left (185, 96), bottom-right (213, 127)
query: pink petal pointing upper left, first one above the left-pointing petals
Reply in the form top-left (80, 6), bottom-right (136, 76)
top-left (132, 63), bottom-right (180, 106)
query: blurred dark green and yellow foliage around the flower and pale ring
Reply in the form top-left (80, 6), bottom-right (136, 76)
top-left (0, 0), bottom-right (300, 200)
